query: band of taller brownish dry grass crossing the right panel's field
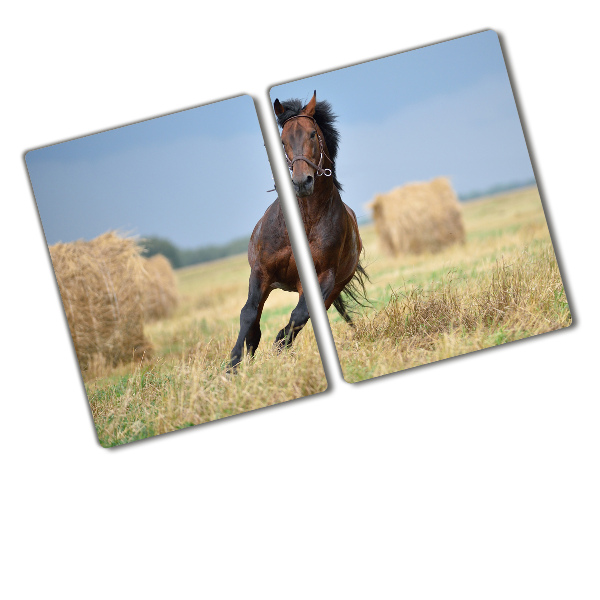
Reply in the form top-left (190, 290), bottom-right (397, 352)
top-left (354, 249), bottom-right (569, 348)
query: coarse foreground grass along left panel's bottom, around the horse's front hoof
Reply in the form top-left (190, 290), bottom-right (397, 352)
top-left (88, 332), bottom-right (327, 446)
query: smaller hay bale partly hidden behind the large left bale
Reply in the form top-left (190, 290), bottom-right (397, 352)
top-left (142, 254), bottom-right (179, 321)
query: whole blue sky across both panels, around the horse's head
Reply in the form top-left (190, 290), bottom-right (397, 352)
top-left (26, 31), bottom-right (533, 248)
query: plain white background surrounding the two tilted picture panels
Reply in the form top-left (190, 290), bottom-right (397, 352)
top-left (0, 0), bottom-right (600, 600)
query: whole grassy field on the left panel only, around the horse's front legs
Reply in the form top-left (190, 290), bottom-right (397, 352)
top-left (84, 247), bottom-right (327, 446)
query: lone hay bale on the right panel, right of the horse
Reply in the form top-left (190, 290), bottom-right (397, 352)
top-left (367, 177), bottom-right (465, 256)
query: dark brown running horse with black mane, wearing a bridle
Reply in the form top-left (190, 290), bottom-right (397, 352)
top-left (230, 92), bottom-right (366, 368)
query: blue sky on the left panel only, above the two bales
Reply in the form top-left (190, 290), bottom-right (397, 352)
top-left (26, 96), bottom-right (275, 248)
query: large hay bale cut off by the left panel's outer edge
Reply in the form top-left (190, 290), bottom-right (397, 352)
top-left (50, 232), bottom-right (151, 371)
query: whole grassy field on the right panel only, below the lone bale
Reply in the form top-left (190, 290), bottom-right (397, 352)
top-left (330, 190), bottom-right (571, 382)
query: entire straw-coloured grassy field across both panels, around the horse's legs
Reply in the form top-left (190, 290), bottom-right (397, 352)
top-left (84, 188), bottom-right (571, 446)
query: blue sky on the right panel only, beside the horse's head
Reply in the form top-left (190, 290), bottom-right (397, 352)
top-left (270, 31), bottom-right (534, 220)
